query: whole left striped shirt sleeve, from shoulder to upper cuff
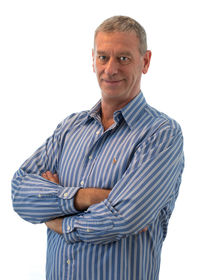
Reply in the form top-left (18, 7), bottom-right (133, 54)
top-left (12, 116), bottom-right (79, 223)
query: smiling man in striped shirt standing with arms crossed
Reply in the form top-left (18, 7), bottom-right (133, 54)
top-left (12, 16), bottom-right (184, 280)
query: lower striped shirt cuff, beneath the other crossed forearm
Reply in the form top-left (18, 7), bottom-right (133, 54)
top-left (62, 216), bottom-right (80, 243)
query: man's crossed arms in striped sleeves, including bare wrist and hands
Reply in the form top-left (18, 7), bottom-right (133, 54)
top-left (12, 115), bottom-right (183, 244)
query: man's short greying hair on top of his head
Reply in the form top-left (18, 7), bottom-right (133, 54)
top-left (94, 16), bottom-right (147, 55)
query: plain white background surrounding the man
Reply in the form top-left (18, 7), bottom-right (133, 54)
top-left (0, 0), bottom-right (200, 280)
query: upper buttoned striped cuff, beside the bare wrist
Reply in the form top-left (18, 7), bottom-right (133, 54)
top-left (58, 187), bottom-right (80, 215)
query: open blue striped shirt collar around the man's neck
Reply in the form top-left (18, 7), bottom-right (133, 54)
top-left (88, 91), bottom-right (147, 129)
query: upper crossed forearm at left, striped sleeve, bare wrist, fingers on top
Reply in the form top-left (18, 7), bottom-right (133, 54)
top-left (12, 167), bottom-right (110, 223)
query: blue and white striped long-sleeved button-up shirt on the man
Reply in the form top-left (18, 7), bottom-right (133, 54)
top-left (12, 92), bottom-right (184, 280)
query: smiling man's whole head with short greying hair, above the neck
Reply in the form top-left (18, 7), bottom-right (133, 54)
top-left (93, 16), bottom-right (151, 104)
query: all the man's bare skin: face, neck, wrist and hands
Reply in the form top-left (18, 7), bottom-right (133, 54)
top-left (42, 32), bottom-right (151, 234)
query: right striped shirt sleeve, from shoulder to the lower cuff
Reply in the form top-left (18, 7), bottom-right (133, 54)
top-left (63, 122), bottom-right (184, 244)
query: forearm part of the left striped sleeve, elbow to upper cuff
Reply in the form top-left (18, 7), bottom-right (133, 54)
top-left (12, 170), bottom-right (79, 223)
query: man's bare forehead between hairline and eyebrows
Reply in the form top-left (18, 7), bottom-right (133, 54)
top-left (95, 32), bottom-right (139, 52)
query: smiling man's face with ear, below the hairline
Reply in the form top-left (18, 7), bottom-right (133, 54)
top-left (93, 32), bottom-right (151, 103)
